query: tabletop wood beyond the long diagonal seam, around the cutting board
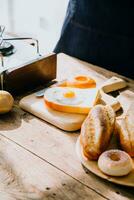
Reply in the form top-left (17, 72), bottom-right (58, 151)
top-left (0, 54), bottom-right (134, 200)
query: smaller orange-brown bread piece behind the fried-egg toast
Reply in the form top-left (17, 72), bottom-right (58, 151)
top-left (59, 75), bottom-right (96, 88)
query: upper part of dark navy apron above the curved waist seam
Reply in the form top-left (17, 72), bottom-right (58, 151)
top-left (72, 0), bottom-right (134, 37)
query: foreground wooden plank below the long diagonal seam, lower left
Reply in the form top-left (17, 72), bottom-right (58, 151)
top-left (0, 136), bottom-right (105, 200)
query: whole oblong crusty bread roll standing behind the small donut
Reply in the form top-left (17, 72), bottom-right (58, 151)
top-left (80, 105), bottom-right (115, 160)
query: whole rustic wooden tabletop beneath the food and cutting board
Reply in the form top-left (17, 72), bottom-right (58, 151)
top-left (0, 54), bottom-right (134, 200)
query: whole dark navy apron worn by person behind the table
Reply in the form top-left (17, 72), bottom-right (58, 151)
top-left (54, 0), bottom-right (134, 78)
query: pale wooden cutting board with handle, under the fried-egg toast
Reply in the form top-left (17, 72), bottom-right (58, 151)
top-left (19, 77), bottom-right (126, 131)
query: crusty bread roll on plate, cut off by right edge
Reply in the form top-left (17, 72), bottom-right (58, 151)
top-left (116, 103), bottom-right (134, 157)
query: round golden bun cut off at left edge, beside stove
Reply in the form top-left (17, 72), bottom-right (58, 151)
top-left (0, 90), bottom-right (14, 114)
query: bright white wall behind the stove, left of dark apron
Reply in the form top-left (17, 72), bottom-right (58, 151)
top-left (0, 0), bottom-right (68, 53)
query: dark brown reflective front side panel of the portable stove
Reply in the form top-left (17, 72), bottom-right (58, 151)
top-left (4, 54), bottom-right (56, 94)
